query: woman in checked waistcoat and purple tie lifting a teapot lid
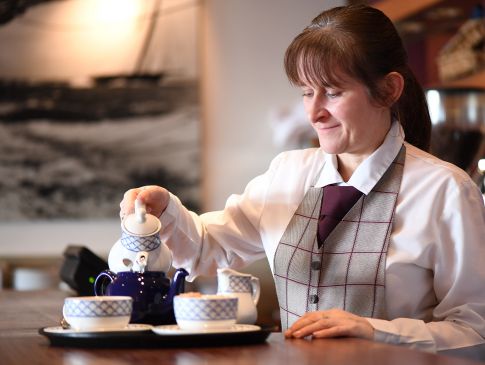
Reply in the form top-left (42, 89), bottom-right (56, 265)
top-left (120, 5), bottom-right (485, 356)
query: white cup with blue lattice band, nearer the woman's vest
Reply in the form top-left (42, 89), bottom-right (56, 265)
top-left (173, 294), bottom-right (238, 331)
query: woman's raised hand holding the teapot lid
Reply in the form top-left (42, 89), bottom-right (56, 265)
top-left (120, 185), bottom-right (170, 220)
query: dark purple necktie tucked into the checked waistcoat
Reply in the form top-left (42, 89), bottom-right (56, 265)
top-left (317, 185), bottom-right (363, 248)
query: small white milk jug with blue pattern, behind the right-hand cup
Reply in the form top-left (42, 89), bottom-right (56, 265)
top-left (217, 268), bottom-right (261, 324)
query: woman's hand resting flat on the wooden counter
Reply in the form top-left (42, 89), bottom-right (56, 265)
top-left (285, 309), bottom-right (374, 340)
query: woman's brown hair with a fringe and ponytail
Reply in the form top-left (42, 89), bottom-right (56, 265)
top-left (285, 5), bottom-right (431, 151)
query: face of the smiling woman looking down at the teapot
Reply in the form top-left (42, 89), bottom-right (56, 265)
top-left (302, 74), bottom-right (391, 158)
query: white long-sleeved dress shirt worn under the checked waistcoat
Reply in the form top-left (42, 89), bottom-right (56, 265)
top-left (160, 122), bottom-right (485, 356)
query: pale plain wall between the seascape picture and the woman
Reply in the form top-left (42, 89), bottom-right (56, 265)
top-left (201, 0), bottom-right (345, 210)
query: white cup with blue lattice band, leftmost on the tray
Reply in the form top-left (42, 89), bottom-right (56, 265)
top-left (62, 296), bottom-right (133, 331)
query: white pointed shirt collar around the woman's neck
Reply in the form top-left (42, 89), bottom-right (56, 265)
top-left (315, 121), bottom-right (404, 195)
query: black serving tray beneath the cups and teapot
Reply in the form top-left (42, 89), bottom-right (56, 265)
top-left (39, 327), bottom-right (275, 348)
